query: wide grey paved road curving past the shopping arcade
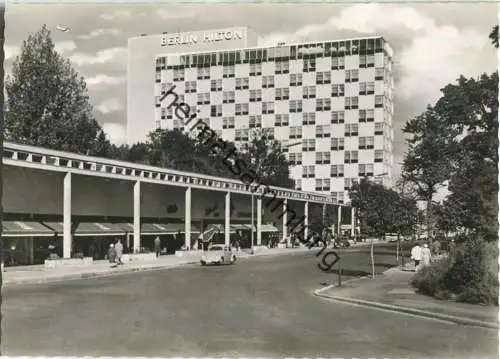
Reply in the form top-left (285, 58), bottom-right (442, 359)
top-left (2, 250), bottom-right (498, 358)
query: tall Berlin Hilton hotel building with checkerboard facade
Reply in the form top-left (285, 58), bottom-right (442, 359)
top-left (127, 28), bottom-right (394, 203)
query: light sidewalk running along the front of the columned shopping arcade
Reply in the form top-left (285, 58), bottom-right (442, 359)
top-left (2, 248), bottom-right (308, 286)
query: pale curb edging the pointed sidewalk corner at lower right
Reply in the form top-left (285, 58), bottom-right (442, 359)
top-left (313, 268), bottom-right (500, 330)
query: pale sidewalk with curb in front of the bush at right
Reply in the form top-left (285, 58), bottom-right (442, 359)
top-left (314, 268), bottom-right (499, 329)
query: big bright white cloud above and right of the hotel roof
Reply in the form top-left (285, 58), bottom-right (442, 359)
top-left (262, 4), bottom-right (496, 110)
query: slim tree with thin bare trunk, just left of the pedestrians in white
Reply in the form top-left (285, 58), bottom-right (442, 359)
top-left (402, 106), bottom-right (459, 242)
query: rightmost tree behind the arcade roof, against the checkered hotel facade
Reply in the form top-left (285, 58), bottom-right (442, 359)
top-left (242, 130), bottom-right (294, 188)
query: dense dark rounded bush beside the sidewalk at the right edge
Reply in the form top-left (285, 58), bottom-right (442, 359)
top-left (410, 238), bottom-right (499, 305)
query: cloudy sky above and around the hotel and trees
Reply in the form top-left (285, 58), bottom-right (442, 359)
top-left (5, 3), bottom-right (498, 174)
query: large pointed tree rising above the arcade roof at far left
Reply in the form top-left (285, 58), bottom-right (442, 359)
top-left (5, 26), bottom-right (105, 154)
